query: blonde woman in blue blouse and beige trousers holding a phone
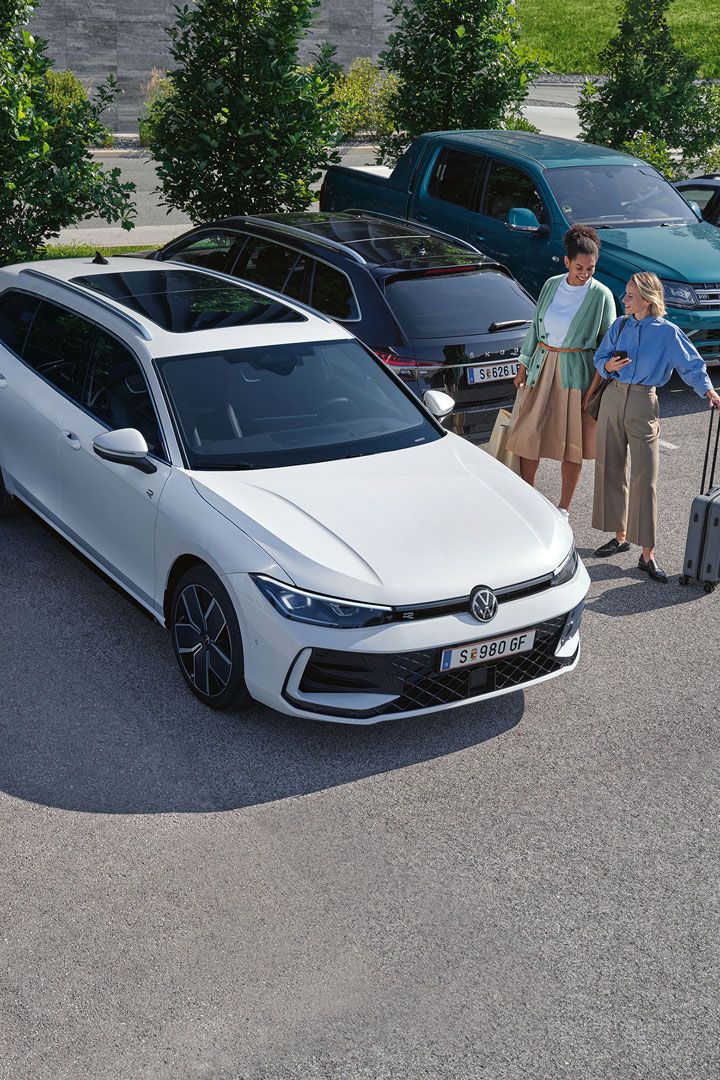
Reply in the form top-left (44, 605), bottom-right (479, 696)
top-left (593, 272), bottom-right (720, 582)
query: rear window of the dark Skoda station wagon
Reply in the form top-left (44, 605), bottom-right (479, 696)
top-left (385, 270), bottom-right (534, 341)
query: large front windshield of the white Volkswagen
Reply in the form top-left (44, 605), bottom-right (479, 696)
top-left (155, 341), bottom-right (443, 470)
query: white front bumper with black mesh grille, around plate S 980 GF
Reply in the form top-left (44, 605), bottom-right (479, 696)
top-left (226, 563), bottom-right (589, 724)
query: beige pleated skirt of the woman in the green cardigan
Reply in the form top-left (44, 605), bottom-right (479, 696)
top-left (507, 352), bottom-right (597, 464)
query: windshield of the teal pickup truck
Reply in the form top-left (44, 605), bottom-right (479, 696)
top-left (545, 165), bottom-right (697, 229)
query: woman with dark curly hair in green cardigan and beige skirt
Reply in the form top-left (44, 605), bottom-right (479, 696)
top-left (507, 225), bottom-right (615, 514)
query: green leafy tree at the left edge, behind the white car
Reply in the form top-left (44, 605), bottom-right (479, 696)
top-left (0, 0), bottom-right (135, 262)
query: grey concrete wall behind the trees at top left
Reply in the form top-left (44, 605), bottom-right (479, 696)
top-left (30, 0), bottom-right (390, 132)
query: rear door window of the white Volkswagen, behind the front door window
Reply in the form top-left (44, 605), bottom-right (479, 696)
top-left (23, 300), bottom-right (97, 402)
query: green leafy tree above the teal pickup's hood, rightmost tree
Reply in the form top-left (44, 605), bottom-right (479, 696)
top-left (578, 0), bottom-right (720, 167)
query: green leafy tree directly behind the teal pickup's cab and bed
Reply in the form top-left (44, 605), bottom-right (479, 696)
top-left (379, 0), bottom-right (540, 163)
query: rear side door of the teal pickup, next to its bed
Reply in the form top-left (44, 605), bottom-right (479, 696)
top-left (409, 146), bottom-right (487, 247)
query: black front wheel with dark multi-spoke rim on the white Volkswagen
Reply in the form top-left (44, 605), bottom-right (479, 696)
top-left (169, 566), bottom-right (249, 708)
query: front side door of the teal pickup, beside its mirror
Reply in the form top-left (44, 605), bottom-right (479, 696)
top-left (467, 158), bottom-right (562, 297)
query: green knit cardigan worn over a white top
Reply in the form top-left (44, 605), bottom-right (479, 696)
top-left (518, 273), bottom-right (617, 392)
